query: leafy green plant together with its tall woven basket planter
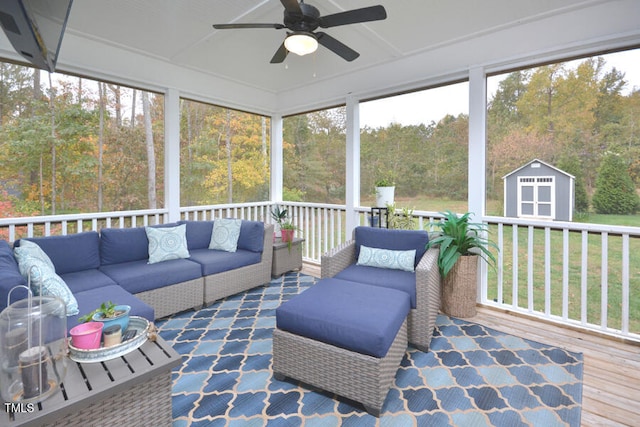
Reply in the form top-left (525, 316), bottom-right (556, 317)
top-left (427, 211), bottom-right (499, 317)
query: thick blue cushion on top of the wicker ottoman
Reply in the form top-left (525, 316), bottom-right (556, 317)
top-left (276, 278), bottom-right (409, 358)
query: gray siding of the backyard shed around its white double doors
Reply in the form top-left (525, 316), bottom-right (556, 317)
top-left (503, 160), bottom-right (575, 221)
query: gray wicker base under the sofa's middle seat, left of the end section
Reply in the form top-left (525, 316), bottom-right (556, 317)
top-left (135, 277), bottom-right (204, 319)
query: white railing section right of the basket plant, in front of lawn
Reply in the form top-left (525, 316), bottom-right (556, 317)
top-left (481, 217), bottom-right (640, 340)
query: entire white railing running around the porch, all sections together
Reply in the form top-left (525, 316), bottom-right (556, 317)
top-left (0, 202), bottom-right (640, 341)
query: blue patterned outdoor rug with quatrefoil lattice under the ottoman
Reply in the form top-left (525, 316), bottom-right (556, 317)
top-left (157, 273), bottom-right (583, 427)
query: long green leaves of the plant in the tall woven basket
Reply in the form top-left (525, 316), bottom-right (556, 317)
top-left (427, 211), bottom-right (499, 277)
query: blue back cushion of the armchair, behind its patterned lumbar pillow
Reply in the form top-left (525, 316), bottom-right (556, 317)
top-left (354, 226), bottom-right (429, 266)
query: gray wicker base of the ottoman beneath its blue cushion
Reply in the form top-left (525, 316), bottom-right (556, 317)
top-left (273, 320), bottom-right (407, 417)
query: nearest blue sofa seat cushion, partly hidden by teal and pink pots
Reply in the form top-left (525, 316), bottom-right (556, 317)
top-left (67, 285), bottom-right (155, 330)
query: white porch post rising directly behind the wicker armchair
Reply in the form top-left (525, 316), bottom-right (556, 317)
top-left (345, 96), bottom-right (360, 240)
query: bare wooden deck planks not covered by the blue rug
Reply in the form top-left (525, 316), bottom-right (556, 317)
top-left (303, 264), bottom-right (640, 427)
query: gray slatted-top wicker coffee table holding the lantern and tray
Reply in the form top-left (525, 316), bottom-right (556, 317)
top-left (0, 337), bottom-right (182, 427)
